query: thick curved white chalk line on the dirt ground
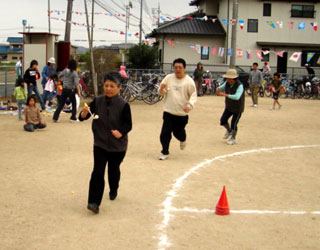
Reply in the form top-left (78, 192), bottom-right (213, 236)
top-left (157, 145), bottom-right (320, 250)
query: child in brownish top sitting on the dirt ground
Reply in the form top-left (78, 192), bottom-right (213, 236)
top-left (24, 95), bottom-right (47, 132)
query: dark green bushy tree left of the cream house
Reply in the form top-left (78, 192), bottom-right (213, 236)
top-left (127, 43), bottom-right (158, 69)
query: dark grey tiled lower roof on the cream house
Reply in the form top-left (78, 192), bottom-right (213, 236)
top-left (148, 17), bottom-right (226, 37)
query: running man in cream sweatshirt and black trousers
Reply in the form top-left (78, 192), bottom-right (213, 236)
top-left (159, 58), bottom-right (197, 160)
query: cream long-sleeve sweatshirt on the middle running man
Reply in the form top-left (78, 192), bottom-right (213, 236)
top-left (160, 73), bottom-right (197, 116)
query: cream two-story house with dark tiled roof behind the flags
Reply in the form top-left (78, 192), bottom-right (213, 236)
top-left (151, 0), bottom-right (320, 73)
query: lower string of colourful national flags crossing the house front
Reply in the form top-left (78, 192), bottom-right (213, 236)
top-left (167, 40), bottom-right (316, 62)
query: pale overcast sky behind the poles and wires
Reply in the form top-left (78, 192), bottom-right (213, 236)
top-left (0, 0), bottom-right (195, 47)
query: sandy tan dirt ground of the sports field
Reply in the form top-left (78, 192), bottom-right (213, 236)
top-left (0, 96), bottom-right (320, 250)
